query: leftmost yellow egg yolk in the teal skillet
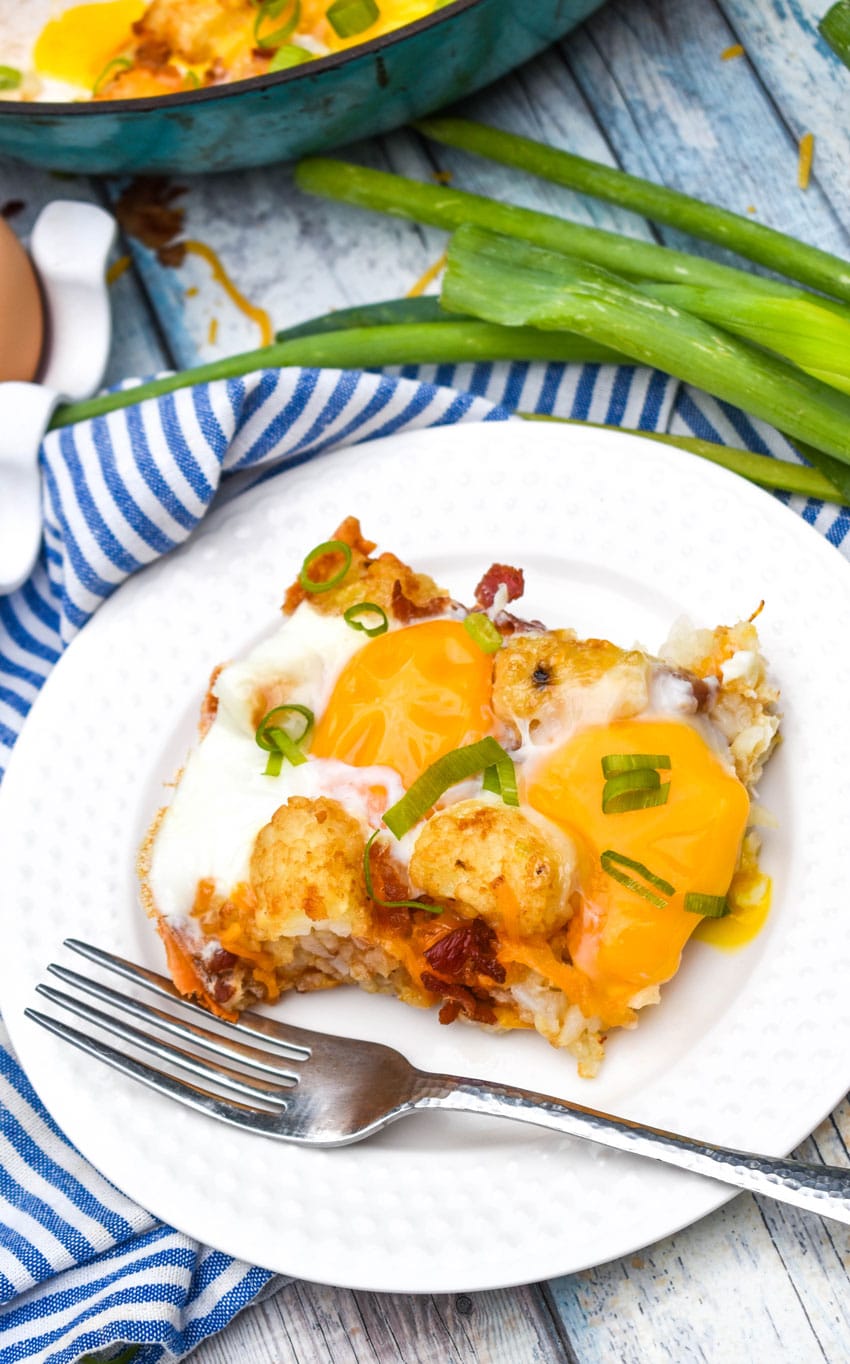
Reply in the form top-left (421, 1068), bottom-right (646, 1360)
top-left (33, 0), bottom-right (147, 90)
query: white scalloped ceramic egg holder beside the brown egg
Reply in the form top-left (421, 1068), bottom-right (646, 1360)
top-left (0, 199), bottom-right (116, 596)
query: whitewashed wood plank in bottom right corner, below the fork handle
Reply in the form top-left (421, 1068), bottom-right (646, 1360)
top-left (550, 1162), bottom-right (847, 1364)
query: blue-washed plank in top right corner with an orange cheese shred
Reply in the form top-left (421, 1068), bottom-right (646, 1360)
top-left (719, 0), bottom-right (850, 225)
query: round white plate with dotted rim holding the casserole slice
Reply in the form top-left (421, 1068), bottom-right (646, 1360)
top-left (0, 423), bottom-right (850, 1292)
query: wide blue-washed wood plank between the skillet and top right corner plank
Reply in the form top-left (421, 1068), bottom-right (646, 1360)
top-left (561, 0), bottom-right (850, 256)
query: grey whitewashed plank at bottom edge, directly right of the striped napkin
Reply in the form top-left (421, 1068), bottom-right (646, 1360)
top-left (185, 1282), bottom-right (569, 1364)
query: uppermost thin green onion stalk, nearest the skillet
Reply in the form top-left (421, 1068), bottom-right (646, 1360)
top-left (416, 117), bottom-right (850, 301)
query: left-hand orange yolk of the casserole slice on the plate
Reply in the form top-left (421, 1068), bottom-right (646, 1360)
top-left (310, 621), bottom-right (493, 786)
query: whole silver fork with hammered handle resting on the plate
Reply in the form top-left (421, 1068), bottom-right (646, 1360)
top-left (25, 938), bottom-right (850, 1224)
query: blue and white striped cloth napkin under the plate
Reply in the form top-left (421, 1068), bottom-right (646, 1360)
top-left (0, 364), bottom-right (850, 1364)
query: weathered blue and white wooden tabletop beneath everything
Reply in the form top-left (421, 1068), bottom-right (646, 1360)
top-left (0, 0), bottom-right (850, 1364)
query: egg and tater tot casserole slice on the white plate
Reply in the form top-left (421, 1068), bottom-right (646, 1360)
top-left (141, 520), bottom-right (779, 1075)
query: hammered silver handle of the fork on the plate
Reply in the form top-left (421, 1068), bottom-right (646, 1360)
top-left (413, 1072), bottom-right (850, 1225)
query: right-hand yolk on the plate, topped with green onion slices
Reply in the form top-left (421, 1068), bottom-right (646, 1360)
top-left (525, 720), bottom-right (749, 1023)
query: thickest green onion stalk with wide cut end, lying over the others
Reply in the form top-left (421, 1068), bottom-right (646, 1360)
top-left (441, 226), bottom-right (850, 464)
